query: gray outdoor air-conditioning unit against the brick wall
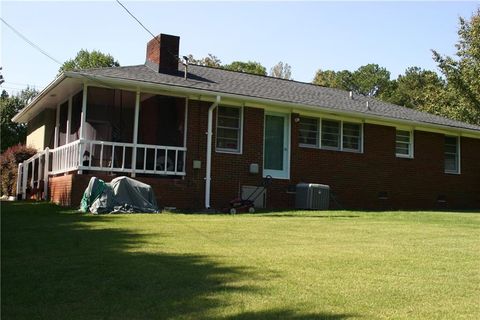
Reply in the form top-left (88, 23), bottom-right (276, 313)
top-left (295, 183), bottom-right (330, 210)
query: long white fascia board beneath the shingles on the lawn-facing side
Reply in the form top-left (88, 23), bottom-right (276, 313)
top-left (65, 72), bottom-right (480, 139)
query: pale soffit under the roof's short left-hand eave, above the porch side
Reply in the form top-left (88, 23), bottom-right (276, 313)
top-left (12, 75), bottom-right (83, 123)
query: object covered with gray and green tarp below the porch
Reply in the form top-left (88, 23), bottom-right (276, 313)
top-left (80, 177), bottom-right (159, 213)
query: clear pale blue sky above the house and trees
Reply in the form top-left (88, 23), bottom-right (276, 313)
top-left (0, 0), bottom-right (480, 94)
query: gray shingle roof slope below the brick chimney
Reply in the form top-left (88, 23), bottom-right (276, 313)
top-left (73, 65), bottom-right (480, 131)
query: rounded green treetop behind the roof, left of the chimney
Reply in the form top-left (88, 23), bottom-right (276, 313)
top-left (58, 49), bottom-right (120, 73)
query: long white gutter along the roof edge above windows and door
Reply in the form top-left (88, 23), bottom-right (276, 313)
top-left (65, 72), bottom-right (480, 139)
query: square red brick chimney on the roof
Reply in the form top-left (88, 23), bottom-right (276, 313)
top-left (145, 34), bottom-right (180, 73)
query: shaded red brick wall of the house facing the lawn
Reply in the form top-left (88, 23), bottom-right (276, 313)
top-left (50, 101), bottom-right (480, 209)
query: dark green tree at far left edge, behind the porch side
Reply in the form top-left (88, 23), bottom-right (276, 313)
top-left (0, 87), bottom-right (38, 152)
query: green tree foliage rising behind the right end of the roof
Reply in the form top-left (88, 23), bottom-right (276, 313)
top-left (313, 9), bottom-right (480, 125)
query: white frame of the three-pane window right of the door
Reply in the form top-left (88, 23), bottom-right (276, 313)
top-left (298, 115), bottom-right (364, 153)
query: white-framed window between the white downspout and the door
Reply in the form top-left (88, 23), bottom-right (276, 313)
top-left (217, 106), bottom-right (243, 153)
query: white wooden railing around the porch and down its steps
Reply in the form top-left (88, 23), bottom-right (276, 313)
top-left (17, 140), bottom-right (187, 199)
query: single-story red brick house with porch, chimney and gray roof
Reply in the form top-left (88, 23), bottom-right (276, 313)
top-left (14, 34), bottom-right (480, 209)
